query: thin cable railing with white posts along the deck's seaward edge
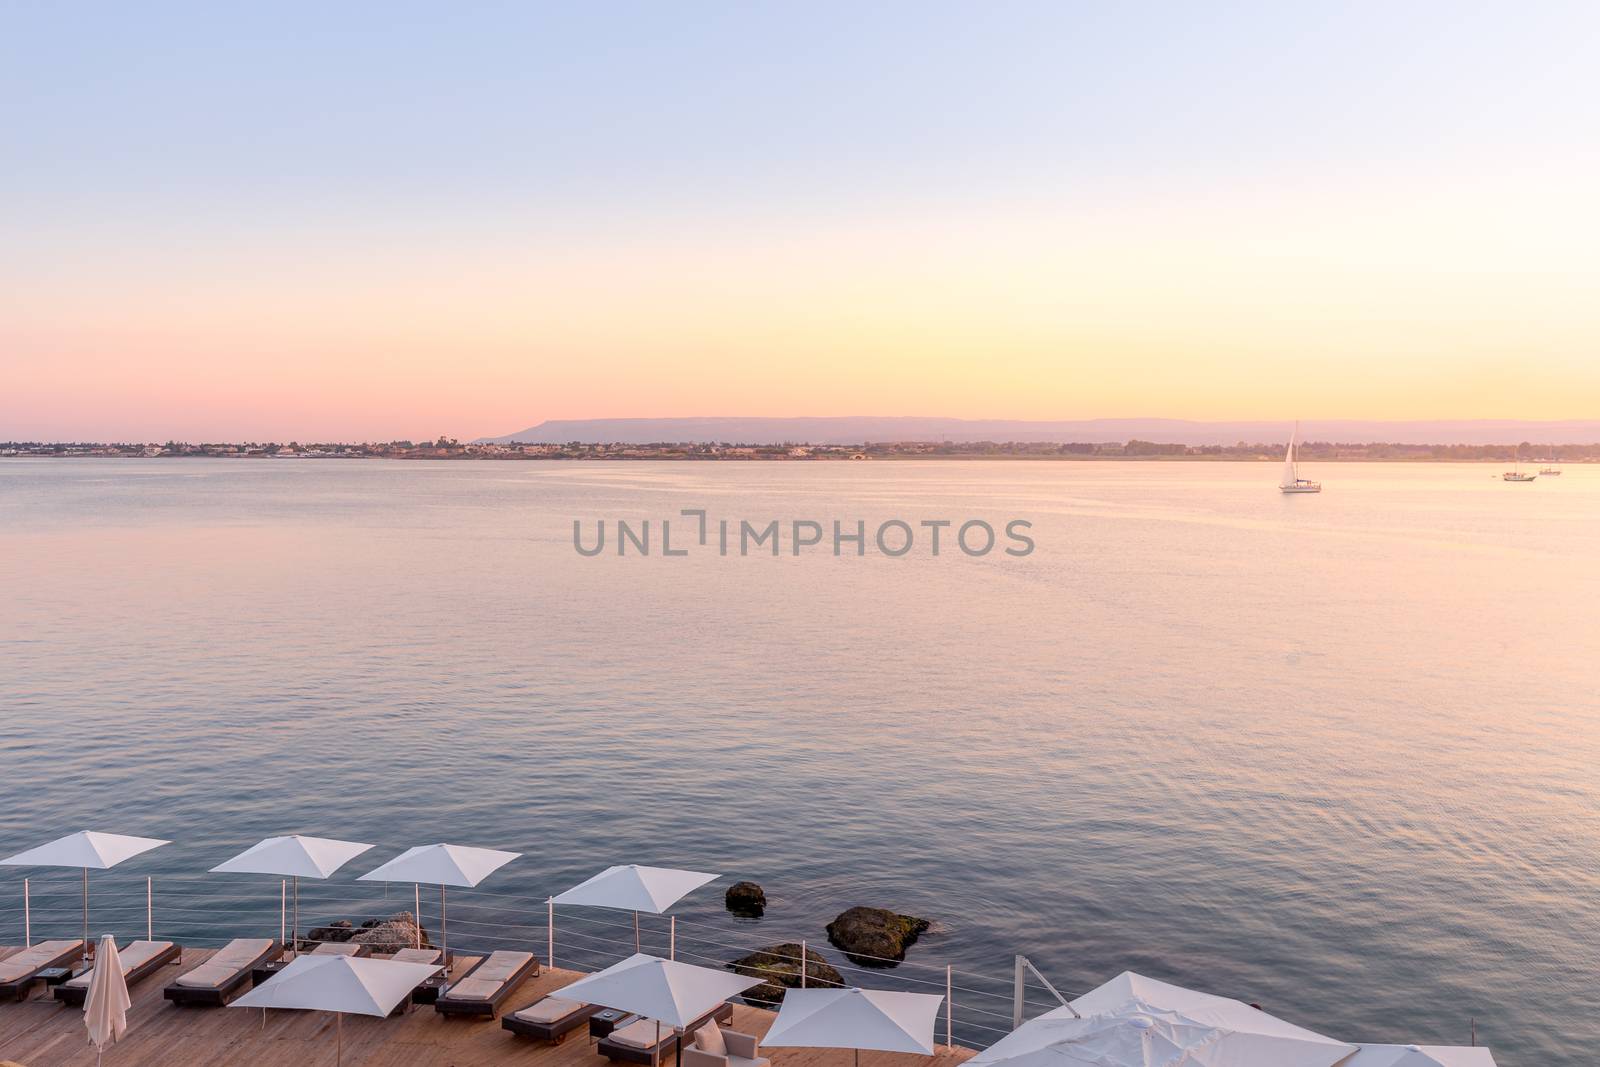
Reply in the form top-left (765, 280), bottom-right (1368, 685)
top-left (0, 875), bottom-right (1059, 1046)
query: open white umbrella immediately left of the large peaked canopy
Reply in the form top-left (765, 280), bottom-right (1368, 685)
top-left (762, 989), bottom-right (944, 1064)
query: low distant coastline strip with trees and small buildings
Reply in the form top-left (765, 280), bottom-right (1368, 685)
top-left (0, 437), bottom-right (1600, 464)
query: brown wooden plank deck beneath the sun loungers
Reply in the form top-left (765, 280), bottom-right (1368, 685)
top-left (0, 949), bottom-right (973, 1067)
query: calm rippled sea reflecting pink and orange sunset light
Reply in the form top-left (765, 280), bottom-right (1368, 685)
top-left (0, 459), bottom-right (1600, 1067)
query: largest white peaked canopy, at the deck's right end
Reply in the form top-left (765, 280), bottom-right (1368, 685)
top-left (970, 971), bottom-right (1357, 1067)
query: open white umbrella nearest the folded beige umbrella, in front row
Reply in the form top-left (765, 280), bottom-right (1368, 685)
top-left (229, 955), bottom-right (440, 1062)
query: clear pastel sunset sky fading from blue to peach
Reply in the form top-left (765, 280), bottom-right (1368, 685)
top-left (0, 0), bottom-right (1600, 440)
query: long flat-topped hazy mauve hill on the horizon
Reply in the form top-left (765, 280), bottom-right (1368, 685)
top-left (478, 416), bottom-right (1600, 445)
